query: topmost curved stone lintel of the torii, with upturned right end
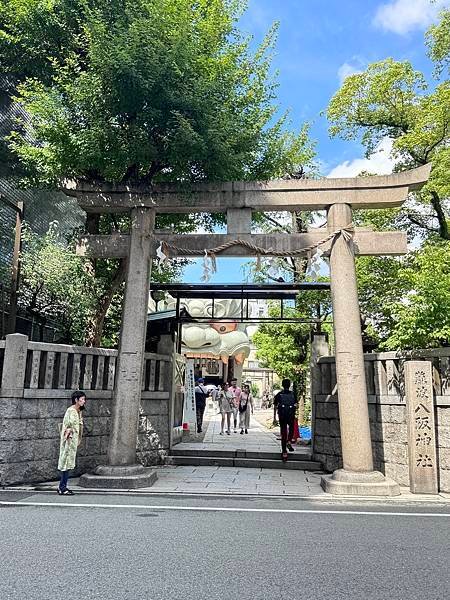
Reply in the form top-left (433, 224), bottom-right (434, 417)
top-left (63, 165), bottom-right (431, 213)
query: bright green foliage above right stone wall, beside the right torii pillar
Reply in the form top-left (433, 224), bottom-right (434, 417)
top-left (357, 239), bottom-right (450, 350)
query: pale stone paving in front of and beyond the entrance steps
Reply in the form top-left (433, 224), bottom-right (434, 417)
top-left (5, 408), bottom-right (450, 504)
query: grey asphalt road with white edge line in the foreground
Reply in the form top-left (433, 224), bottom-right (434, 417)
top-left (0, 492), bottom-right (450, 600)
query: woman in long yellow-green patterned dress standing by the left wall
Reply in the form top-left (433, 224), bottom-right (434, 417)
top-left (58, 390), bottom-right (86, 496)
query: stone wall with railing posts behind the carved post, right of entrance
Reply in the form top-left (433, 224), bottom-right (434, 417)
top-left (313, 348), bottom-right (450, 492)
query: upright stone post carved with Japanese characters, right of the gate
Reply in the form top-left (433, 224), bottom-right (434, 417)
top-left (405, 361), bottom-right (438, 494)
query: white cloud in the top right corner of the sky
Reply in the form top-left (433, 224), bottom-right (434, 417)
top-left (372, 0), bottom-right (450, 35)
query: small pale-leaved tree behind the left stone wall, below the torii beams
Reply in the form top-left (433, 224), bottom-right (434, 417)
top-left (19, 221), bottom-right (183, 347)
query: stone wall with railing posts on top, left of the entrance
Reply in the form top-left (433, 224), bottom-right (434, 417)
top-left (0, 334), bottom-right (171, 485)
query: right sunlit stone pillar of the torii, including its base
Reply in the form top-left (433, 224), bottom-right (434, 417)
top-left (321, 204), bottom-right (400, 496)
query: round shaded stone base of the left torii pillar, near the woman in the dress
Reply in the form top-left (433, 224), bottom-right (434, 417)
top-left (78, 465), bottom-right (158, 490)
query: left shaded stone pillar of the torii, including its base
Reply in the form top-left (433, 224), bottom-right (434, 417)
top-left (80, 207), bottom-right (157, 488)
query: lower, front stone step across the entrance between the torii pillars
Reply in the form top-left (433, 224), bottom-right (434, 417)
top-left (170, 453), bottom-right (322, 471)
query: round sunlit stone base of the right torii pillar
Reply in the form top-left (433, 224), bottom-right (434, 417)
top-left (320, 469), bottom-right (400, 496)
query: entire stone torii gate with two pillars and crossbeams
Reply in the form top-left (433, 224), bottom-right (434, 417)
top-left (65, 165), bottom-right (430, 495)
